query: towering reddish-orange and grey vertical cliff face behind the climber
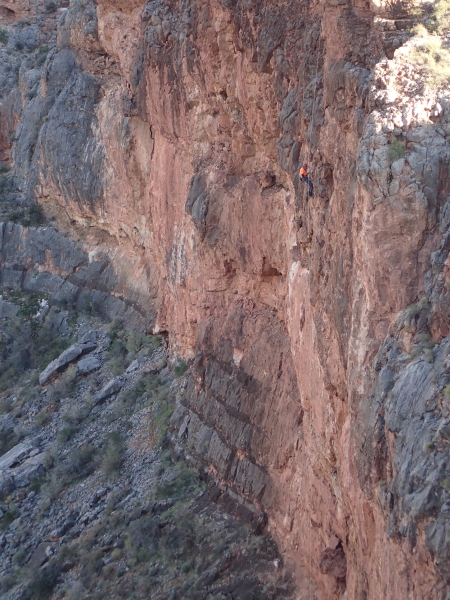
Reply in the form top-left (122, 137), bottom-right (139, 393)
top-left (2, 0), bottom-right (450, 599)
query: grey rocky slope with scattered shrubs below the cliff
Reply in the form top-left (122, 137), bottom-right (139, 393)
top-left (0, 288), bottom-right (292, 600)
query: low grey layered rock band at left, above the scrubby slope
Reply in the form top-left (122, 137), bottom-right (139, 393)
top-left (0, 223), bottom-right (154, 332)
